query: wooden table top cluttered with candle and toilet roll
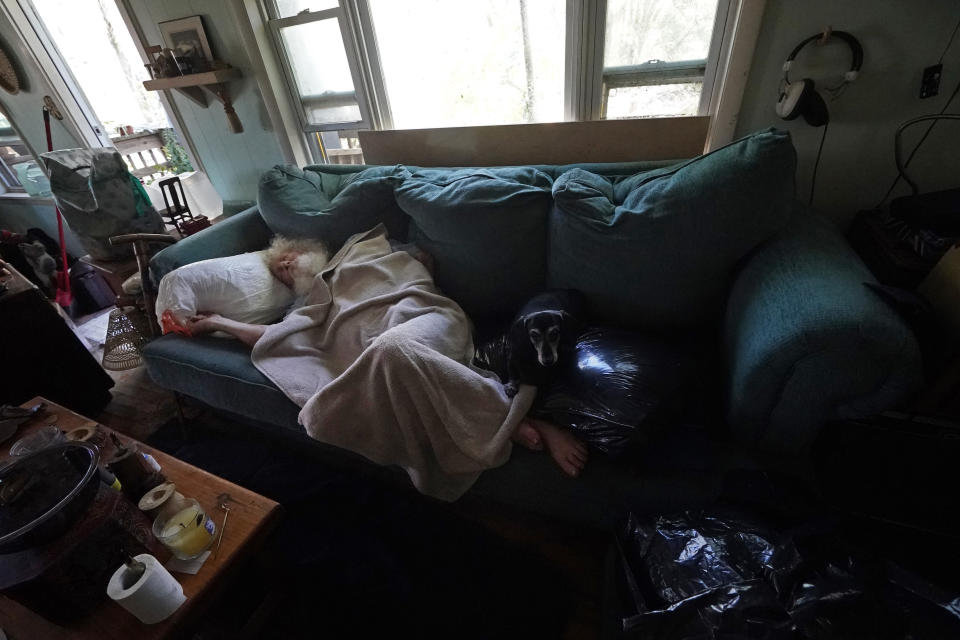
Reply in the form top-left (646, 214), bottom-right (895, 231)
top-left (0, 397), bottom-right (281, 640)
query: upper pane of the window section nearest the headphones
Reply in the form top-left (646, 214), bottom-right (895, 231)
top-left (603, 0), bottom-right (717, 67)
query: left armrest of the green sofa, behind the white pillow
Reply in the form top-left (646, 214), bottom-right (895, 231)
top-left (150, 207), bottom-right (273, 283)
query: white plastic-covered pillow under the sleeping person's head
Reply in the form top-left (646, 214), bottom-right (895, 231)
top-left (157, 251), bottom-right (294, 326)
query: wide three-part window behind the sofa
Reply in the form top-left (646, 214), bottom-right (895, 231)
top-left (261, 0), bottom-right (762, 162)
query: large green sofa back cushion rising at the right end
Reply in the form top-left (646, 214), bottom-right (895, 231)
top-left (547, 129), bottom-right (796, 329)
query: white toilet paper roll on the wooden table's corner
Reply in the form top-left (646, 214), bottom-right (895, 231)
top-left (107, 553), bottom-right (187, 624)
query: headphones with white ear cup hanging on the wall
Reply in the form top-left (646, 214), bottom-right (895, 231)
top-left (777, 27), bottom-right (863, 127)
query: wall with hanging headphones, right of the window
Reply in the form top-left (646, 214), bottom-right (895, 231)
top-left (737, 0), bottom-right (960, 223)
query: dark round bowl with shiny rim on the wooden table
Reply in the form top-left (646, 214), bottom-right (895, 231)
top-left (0, 442), bottom-right (100, 554)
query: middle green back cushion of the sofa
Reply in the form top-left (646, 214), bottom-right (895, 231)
top-left (396, 167), bottom-right (552, 319)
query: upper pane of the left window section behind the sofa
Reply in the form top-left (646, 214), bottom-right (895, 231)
top-left (280, 18), bottom-right (361, 124)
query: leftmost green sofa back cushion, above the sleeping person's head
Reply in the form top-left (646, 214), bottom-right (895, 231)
top-left (258, 165), bottom-right (407, 252)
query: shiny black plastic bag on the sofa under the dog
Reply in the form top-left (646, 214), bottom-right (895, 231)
top-left (474, 327), bottom-right (688, 455)
